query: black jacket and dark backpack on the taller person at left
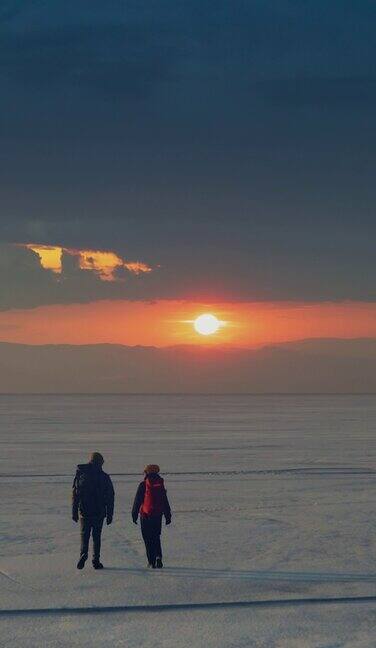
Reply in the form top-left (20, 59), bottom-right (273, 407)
top-left (72, 463), bottom-right (115, 519)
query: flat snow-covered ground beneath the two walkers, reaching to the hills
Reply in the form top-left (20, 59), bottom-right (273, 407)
top-left (0, 396), bottom-right (376, 648)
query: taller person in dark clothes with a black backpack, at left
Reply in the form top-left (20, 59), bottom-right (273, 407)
top-left (72, 452), bottom-right (115, 569)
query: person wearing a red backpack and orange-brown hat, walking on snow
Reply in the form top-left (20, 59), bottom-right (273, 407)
top-left (132, 464), bottom-right (171, 569)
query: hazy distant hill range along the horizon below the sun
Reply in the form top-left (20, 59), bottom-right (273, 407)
top-left (0, 339), bottom-right (376, 393)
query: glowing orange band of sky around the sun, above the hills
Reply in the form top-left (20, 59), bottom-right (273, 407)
top-left (0, 300), bottom-right (376, 348)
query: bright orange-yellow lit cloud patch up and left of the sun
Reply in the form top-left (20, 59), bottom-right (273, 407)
top-left (20, 243), bottom-right (152, 281)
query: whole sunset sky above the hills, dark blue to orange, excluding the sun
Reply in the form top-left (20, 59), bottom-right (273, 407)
top-left (0, 0), bottom-right (376, 347)
